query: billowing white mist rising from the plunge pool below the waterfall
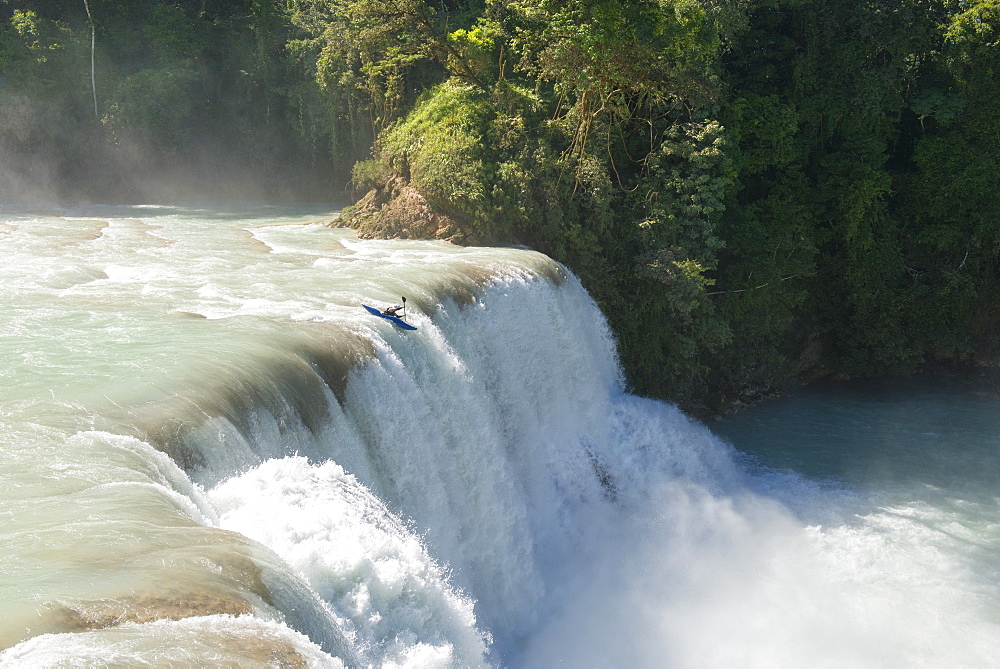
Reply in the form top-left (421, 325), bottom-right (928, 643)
top-left (512, 464), bottom-right (995, 669)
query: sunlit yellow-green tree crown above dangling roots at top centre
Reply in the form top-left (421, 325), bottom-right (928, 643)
top-left (511, 0), bottom-right (720, 167)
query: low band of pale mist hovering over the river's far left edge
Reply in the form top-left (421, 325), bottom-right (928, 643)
top-left (0, 94), bottom-right (345, 204)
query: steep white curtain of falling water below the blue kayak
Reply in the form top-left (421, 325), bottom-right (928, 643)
top-left (129, 266), bottom-right (736, 666)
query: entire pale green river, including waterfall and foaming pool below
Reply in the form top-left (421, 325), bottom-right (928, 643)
top-left (0, 206), bottom-right (1000, 667)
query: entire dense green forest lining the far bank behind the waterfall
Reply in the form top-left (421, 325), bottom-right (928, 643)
top-left (0, 0), bottom-right (1000, 410)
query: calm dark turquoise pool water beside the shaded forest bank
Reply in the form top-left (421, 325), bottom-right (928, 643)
top-left (713, 377), bottom-right (1000, 500)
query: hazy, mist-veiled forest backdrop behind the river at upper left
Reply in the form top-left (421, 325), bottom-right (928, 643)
top-left (0, 2), bottom-right (352, 204)
